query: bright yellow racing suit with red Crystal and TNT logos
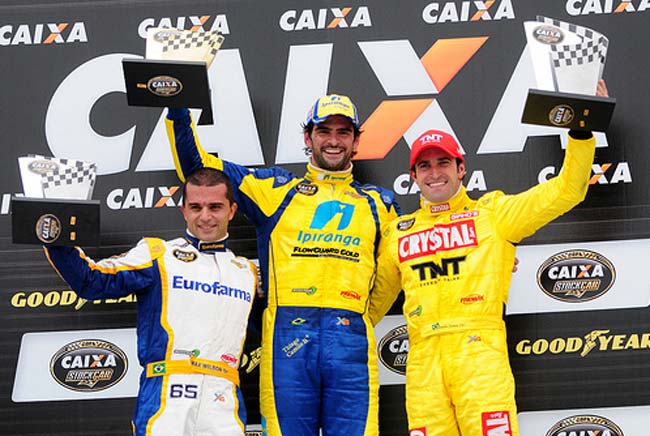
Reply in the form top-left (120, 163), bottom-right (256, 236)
top-left (371, 133), bottom-right (595, 436)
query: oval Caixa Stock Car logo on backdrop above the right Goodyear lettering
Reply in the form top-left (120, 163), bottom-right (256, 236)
top-left (537, 250), bottom-right (616, 303)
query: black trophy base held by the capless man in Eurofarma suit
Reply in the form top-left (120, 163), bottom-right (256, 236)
top-left (11, 197), bottom-right (99, 246)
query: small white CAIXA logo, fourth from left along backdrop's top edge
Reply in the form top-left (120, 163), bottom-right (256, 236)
top-left (422, 0), bottom-right (515, 24)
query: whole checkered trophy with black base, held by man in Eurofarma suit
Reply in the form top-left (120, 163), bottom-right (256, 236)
top-left (11, 155), bottom-right (99, 245)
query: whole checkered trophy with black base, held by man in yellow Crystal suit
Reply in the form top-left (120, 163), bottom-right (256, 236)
top-left (522, 16), bottom-right (615, 131)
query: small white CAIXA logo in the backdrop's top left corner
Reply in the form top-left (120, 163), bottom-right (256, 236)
top-left (0, 21), bottom-right (88, 46)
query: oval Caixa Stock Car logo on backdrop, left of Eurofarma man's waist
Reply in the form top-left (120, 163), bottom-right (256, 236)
top-left (50, 339), bottom-right (129, 392)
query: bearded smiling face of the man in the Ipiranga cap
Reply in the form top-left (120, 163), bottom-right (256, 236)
top-left (305, 115), bottom-right (359, 171)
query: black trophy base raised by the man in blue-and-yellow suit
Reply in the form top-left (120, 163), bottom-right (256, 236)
top-left (122, 58), bottom-right (214, 125)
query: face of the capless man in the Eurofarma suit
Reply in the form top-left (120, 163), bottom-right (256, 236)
top-left (181, 183), bottom-right (237, 242)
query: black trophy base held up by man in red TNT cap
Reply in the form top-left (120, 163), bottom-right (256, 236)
top-left (521, 89), bottom-right (616, 132)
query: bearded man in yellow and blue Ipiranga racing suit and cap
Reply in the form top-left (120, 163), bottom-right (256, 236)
top-left (167, 94), bottom-right (399, 436)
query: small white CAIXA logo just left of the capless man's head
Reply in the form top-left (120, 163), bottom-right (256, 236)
top-left (106, 186), bottom-right (183, 210)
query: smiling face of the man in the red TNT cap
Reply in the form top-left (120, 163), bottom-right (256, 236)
top-left (411, 148), bottom-right (465, 203)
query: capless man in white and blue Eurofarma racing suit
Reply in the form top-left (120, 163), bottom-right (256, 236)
top-left (45, 168), bottom-right (257, 436)
